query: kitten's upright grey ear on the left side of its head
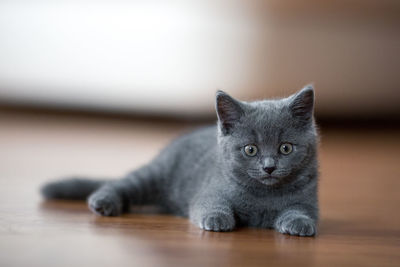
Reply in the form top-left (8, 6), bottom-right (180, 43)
top-left (215, 90), bottom-right (244, 135)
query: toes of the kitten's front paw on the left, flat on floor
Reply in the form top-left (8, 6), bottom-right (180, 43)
top-left (199, 213), bottom-right (235, 232)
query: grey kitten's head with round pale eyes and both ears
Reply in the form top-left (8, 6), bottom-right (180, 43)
top-left (216, 85), bottom-right (317, 186)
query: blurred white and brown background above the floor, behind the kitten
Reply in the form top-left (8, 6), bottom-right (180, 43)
top-left (0, 0), bottom-right (400, 120)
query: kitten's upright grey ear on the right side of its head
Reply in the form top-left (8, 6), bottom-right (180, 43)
top-left (289, 85), bottom-right (314, 123)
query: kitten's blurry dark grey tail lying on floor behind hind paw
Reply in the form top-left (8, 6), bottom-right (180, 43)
top-left (40, 178), bottom-right (106, 200)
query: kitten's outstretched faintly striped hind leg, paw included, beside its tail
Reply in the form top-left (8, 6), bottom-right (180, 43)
top-left (88, 164), bottom-right (162, 216)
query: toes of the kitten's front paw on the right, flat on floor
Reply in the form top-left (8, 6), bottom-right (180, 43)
top-left (277, 217), bottom-right (317, 236)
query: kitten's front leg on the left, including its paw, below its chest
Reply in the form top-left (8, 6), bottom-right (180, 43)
top-left (189, 196), bottom-right (236, 232)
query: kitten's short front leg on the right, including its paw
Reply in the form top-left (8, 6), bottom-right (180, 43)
top-left (274, 206), bottom-right (317, 236)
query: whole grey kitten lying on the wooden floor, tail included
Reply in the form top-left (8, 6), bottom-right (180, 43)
top-left (42, 86), bottom-right (318, 236)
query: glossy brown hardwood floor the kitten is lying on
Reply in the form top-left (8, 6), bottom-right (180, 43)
top-left (0, 112), bottom-right (400, 267)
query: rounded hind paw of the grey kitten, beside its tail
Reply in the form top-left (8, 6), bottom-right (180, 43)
top-left (88, 192), bottom-right (122, 216)
